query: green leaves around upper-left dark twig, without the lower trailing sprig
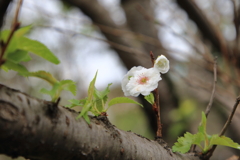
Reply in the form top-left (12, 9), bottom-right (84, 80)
top-left (1, 25), bottom-right (60, 76)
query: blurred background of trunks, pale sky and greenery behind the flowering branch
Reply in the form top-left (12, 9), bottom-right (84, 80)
top-left (0, 0), bottom-right (240, 160)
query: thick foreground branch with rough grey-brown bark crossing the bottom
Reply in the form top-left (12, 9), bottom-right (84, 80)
top-left (0, 85), bottom-right (199, 160)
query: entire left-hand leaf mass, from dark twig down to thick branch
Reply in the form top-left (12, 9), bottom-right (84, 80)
top-left (1, 25), bottom-right (76, 102)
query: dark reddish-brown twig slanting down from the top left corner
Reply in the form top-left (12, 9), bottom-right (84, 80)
top-left (0, 0), bottom-right (23, 66)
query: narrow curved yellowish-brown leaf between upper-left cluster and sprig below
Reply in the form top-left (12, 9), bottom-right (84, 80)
top-left (28, 71), bottom-right (57, 85)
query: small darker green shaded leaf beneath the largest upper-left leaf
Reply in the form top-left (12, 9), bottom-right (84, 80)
top-left (6, 50), bottom-right (32, 63)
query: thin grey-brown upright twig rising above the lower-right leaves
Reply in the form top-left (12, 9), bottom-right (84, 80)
top-left (205, 57), bottom-right (217, 117)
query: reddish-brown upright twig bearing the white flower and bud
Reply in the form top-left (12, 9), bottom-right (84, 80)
top-left (150, 51), bottom-right (162, 139)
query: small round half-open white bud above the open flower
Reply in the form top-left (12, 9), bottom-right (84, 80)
top-left (154, 55), bottom-right (169, 73)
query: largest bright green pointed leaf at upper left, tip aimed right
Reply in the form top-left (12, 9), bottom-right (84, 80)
top-left (17, 37), bottom-right (60, 64)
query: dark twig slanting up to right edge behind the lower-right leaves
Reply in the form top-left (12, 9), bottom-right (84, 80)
top-left (204, 96), bottom-right (240, 159)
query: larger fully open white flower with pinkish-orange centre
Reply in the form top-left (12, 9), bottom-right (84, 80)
top-left (122, 66), bottom-right (162, 97)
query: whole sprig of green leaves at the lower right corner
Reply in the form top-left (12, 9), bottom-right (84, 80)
top-left (172, 112), bottom-right (240, 154)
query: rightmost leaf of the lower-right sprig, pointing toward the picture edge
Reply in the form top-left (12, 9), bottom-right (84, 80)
top-left (210, 134), bottom-right (240, 149)
